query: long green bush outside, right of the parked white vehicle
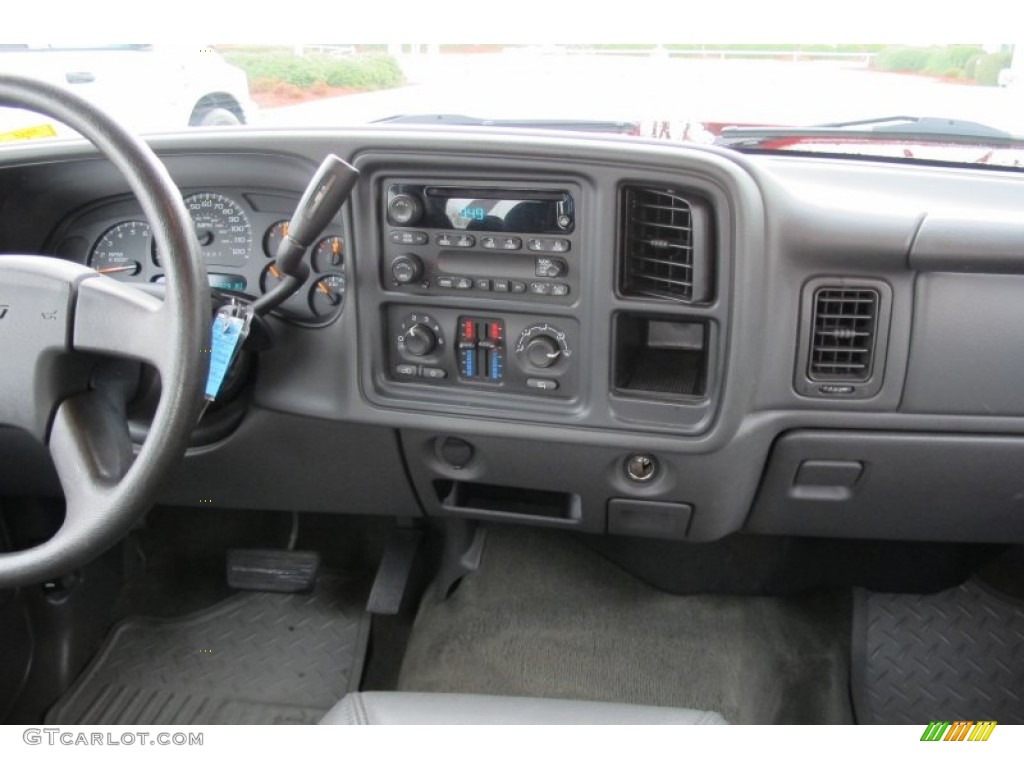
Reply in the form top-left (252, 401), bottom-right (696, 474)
top-left (224, 50), bottom-right (403, 90)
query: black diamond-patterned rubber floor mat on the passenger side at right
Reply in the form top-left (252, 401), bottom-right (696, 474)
top-left (853, 581), bottom-right (1024, 725)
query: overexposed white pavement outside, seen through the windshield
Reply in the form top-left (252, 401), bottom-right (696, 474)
top-left (261, 53), bottom-right (1024, 134)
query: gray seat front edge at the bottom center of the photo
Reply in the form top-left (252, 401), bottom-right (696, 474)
top-left (321, 692), bottom-right (726, 725)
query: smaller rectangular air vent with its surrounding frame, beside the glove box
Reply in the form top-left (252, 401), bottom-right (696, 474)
top-left (797, 278), bottom-right (892, 397)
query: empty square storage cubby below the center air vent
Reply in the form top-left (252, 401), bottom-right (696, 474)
top-left (614, 313), bottom-right (708, 398)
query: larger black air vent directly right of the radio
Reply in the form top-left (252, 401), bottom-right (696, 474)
top-left (621, 186), bottom-right (711, 303)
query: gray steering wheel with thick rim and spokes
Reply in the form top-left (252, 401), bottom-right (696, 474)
top-left (0, 75), bottom-right (211, 588)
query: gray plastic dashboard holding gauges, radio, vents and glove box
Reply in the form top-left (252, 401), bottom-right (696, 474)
top-left (0, 127), bottom-right (1024, 542)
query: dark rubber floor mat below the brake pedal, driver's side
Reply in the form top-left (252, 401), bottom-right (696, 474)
top-left (46, 577), bottom-right (370, 725)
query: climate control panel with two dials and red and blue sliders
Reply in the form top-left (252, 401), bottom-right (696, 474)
top-left (384, 305), bottom-right (579, 397)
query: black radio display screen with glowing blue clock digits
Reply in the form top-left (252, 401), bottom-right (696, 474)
top-left (392, 185), bottom-right (575, 234)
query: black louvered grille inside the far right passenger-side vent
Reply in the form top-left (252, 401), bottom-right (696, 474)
top-left (808, 288), bottom-right (879, 382)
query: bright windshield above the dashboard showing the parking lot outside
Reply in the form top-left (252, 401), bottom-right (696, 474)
top-left (0, 39), bottom-right (1024, 167)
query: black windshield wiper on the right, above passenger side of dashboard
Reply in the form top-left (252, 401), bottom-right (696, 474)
top-left (715, 115), bottom-right (1024, 150)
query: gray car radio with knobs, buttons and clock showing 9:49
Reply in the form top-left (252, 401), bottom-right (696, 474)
top-left (381, 181), bottom-right (581, 304)
